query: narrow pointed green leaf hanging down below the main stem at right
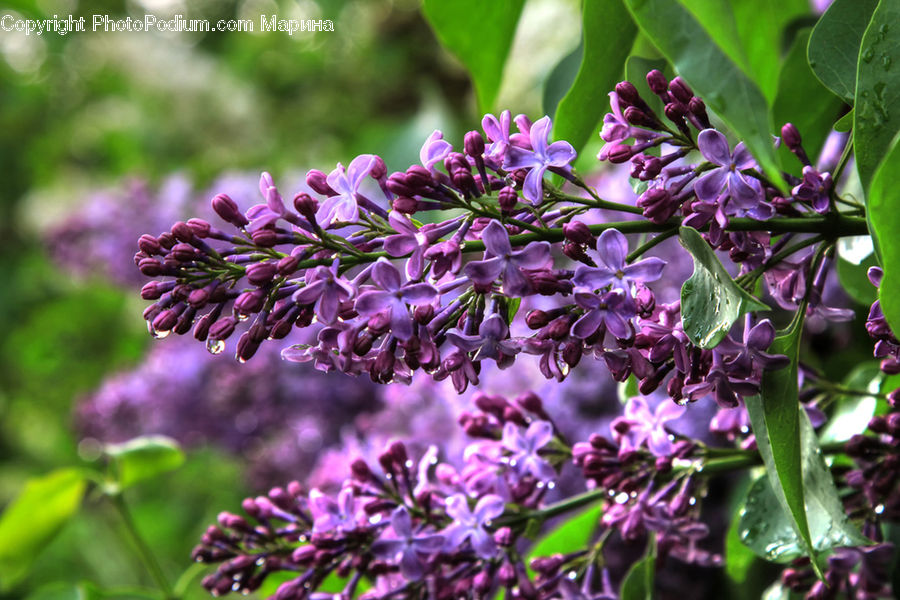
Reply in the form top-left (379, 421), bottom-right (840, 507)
top-left (745, 314), bottom-right (815, 564)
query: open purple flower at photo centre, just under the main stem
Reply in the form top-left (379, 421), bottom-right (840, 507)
top-left (465, 221), bottom-right (550, 297)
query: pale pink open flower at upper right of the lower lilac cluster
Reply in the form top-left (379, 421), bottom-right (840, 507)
top-left (610, 396), bottom-right (685, 456)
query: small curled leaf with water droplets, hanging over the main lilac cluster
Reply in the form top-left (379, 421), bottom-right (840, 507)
top-left (679, 227), bottom-right (769, 349)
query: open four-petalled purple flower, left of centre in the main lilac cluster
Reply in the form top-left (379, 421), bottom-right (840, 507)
top-left (356, 258), bottom-right (438, 340)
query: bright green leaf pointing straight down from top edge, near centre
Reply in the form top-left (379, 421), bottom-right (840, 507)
top-left (422, 0), bottom-right (525, 112)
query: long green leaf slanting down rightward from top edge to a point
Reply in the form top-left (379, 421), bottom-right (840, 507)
top-left (625, 0), bottom-right (782, 182)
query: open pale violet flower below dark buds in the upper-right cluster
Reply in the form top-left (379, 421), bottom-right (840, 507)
top-left (694, 129), bottom-right (760, 207)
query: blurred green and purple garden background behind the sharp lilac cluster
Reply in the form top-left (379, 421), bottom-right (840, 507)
top-left (0, 0), bottom-right (580, 600)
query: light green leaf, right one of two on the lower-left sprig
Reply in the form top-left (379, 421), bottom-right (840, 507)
top-left (104, 435), bottom-right (184, 491)
